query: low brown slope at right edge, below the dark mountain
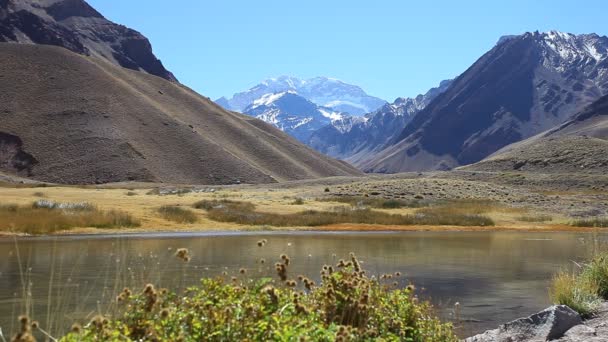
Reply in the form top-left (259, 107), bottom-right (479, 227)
top-left (463, 96), bottom-right (608, 174)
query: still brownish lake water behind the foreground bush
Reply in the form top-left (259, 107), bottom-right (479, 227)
top-left (0, 232), bottom-right (608, 335)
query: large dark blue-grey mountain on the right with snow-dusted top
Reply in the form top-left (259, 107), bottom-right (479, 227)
top-left (357, 31), bottom-right (608, 173)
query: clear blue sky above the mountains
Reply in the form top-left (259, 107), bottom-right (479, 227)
top-left (89, 0), bottom-right (608, 101)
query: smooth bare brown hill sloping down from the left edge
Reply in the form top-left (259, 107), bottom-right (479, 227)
top-left (0, 43), bottom-right (360, 184)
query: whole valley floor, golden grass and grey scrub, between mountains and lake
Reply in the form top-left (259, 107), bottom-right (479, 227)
top-left (0, 171), bottom-right (608, 235)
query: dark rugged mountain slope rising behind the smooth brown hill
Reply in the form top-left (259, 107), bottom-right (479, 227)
top-left (0, 0), bottom-right (176, 81)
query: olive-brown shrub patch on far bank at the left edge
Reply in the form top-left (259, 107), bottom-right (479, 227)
top-left (0, 200), bottom-right (140, 234)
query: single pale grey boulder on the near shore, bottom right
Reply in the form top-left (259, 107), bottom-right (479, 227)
top-left (465, 305), bottom-right (582, 342)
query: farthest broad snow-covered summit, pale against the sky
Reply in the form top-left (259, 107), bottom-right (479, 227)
top-left (215, 76), bottom-right (386, 115)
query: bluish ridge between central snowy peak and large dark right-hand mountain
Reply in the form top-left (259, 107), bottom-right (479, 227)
top-left (308, 80), bottom-right (451, 160)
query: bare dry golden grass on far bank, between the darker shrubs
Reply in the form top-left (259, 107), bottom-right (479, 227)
top-left (0, 184), bottom-right (585, 234)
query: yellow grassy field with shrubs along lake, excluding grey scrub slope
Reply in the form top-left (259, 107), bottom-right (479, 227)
top-left (0, 180), bottom-right (588, 234)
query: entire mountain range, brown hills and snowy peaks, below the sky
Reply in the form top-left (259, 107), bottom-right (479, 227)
top-left (0, 0), bottom-right (608, 184)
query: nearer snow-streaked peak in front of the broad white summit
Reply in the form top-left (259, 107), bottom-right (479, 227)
top-left (243, 91), bottom-right (351, 143)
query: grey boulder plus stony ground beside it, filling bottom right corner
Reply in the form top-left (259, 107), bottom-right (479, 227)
top-left (464, 303), bottom-right (608, 342)
